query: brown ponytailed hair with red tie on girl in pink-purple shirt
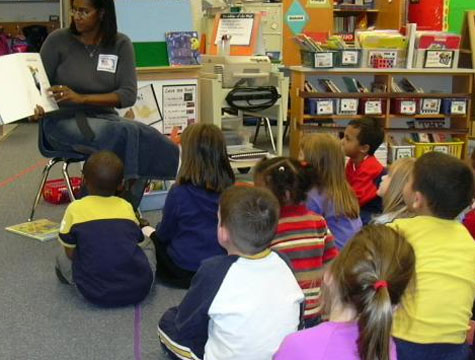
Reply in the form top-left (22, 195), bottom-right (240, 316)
top-left (323, 225), bottom-right (416, 360)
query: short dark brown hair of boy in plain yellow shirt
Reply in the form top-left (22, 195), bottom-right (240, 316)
top-left (412, 151), bottom-right (474, 219)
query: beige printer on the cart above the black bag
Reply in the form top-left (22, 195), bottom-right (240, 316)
top-left (201, 55), bottom-right (272, 88)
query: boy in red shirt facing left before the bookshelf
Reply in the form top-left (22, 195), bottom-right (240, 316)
top-left (342, 119), bottom-right (386, 225)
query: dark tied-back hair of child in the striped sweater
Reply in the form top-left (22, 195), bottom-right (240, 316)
top-left (254, 156), bottom-right (316, 205)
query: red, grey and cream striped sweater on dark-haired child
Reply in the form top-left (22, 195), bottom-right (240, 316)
top-left (271, 204), bottom-right (338, 319)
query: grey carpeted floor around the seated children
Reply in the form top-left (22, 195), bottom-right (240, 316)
top-left (0, 123), bottom-right (278, 360)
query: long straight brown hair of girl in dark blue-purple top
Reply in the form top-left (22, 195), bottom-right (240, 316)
top-left (177, 123), bottom-right (234, 193)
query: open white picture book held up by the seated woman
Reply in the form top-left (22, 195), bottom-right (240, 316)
top-left (0, 53), bottom-right (58, 125)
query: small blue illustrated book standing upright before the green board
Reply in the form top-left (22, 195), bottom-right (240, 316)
top-left (165, 31), bottom-right (200, 65)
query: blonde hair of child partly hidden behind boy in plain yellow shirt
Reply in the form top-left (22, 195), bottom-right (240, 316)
top-left (383, 158), bottom-right (416, 214)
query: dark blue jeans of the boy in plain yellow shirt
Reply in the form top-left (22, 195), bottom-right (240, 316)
top-left (394, 338), bottom-right (470, 360)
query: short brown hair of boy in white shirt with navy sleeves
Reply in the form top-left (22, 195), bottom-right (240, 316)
top-left (219, 186), bottom-right (280, 255)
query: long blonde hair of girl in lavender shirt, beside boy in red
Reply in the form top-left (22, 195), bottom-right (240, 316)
top-left (301, 134), bottom-right (360, 219)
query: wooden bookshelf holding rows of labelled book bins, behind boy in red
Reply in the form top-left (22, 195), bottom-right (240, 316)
top-left (289, 66), bottom-right (475, 158)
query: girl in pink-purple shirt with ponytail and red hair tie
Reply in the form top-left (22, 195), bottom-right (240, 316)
top-left (274, 225), bottom-right (416, 360)
